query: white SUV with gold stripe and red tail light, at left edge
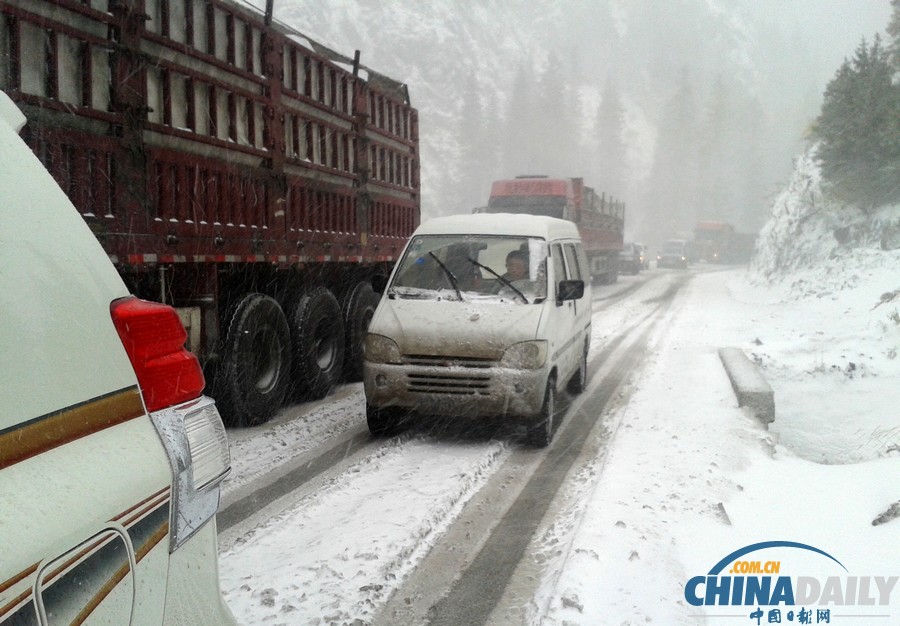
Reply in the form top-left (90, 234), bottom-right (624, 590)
top-left (0, 92), bottom-right (234, 626)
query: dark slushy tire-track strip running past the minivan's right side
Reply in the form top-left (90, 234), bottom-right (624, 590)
top-left (374, 275), bottom-right (689, 626)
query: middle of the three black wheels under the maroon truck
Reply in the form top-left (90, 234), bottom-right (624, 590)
top-left (291, 287), bottom-right (344, 399)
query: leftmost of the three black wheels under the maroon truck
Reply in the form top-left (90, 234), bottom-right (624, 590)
top-left (215, 293), bottom-right (291, 426)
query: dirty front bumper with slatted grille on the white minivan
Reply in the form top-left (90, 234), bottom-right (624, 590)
top-left (363, 358), bottom-right (547, 417)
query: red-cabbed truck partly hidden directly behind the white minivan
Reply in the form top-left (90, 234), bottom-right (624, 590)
top-left (475, 175), bottom-right (625, 283)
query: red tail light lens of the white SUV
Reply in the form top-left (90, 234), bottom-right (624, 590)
top-left (110, 296), bottom-right (206, 412)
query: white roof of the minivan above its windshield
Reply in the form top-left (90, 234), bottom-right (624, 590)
top-left (415, 213), bottom-right (579, 239)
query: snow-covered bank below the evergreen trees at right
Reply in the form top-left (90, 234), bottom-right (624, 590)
top-left (750, 147), bottom-right (900, 463)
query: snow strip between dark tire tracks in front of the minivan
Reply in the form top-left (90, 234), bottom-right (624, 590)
top-left (221, 438), bottom-right (509, 624)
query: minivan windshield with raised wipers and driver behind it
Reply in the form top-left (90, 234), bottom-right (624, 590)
top-left (388, 235), bottom-right (547, 304)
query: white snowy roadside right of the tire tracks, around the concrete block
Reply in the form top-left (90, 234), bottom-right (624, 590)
top-left (542, 258), bottom-right (900, 625)
